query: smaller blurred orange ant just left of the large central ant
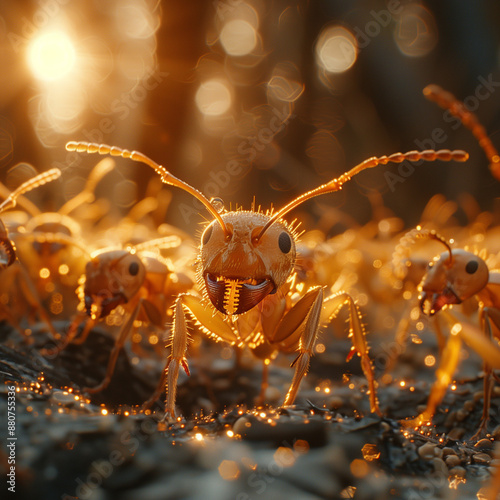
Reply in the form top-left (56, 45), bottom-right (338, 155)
top-left (47, 235), bottom-right (192, 394)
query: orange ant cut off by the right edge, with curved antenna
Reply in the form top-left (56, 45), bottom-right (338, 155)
top-left (396, 226), bottom-right (500, 439)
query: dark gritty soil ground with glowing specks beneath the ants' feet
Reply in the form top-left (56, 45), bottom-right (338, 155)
top-left (0, 318), bottom-right (500, 500)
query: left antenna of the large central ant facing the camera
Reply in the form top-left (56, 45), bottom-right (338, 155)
top-left (66, 141), bottom-right (231, 236)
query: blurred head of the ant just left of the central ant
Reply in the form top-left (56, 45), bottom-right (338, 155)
top-left (84, 250), bottom-right (146, 319)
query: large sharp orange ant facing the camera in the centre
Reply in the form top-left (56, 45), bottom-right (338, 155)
top-left (66, 142), bottom-right (468, 419)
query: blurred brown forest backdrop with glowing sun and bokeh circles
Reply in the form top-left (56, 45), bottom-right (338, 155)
top-left (0, 0), bottom-right (500, 233)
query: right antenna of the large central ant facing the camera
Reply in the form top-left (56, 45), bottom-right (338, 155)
top-left (256, 149), bottom-right (469, 241)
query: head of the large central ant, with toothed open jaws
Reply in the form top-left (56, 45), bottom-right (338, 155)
top-left (198, 210), bottom-right (295, 315)
